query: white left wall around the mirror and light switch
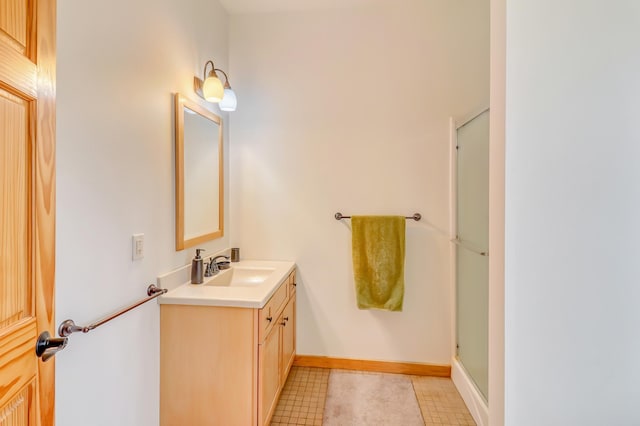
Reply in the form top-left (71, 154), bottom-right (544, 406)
top-left (56, 0), bottom-right (228, 426)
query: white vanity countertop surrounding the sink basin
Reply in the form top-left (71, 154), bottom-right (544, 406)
top-left (158, 260), bottom-right (295, 308)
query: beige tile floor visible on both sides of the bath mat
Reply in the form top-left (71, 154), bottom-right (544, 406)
top-left (271, 367), bottom-right (475, 426)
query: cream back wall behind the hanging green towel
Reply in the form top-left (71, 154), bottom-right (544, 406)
top-left (230, 0), bottom-right (489, 364)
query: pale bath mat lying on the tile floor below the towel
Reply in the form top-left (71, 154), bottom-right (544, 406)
top-left (322, 370), bottom-right (424, 426)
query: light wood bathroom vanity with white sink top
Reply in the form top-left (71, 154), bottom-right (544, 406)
top-left (159, 261), bottom-right (296, 426)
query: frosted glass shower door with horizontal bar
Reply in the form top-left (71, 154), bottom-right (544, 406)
top-left (456, 110), bottom-right (489, 400)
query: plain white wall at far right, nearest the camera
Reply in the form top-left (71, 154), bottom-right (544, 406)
top-left (505, 0), bottom-right (640, 426)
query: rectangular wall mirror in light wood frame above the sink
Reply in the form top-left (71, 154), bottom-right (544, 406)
top-left (175, 93), bottom-right (224, 250)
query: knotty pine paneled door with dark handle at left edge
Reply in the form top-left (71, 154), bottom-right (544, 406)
top-left (0, 0), bottom-right (56, 426)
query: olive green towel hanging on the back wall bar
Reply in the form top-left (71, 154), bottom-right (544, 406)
top-left (351, 216), bottom-right (406, 311)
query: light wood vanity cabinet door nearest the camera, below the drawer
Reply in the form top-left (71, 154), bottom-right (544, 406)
top-left (258, 327), bottom-right (280, 425)
